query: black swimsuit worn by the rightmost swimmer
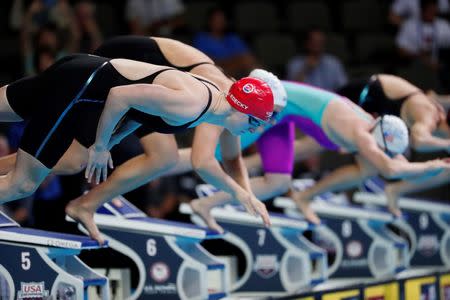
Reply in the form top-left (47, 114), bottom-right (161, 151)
top-left (337, 75), bottom-right (423, 116)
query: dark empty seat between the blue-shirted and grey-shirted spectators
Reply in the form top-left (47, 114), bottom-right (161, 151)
top-left (253, 33), bottom-right (297, 70)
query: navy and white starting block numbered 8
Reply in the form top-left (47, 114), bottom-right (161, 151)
top-left (275, 197), bottom-right (409, 279)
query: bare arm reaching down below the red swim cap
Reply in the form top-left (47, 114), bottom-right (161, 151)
top-left (191, 124), bottom-right (270, 225)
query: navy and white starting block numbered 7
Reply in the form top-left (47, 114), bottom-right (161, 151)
top-left (180, 184), bottom-right (328, 296)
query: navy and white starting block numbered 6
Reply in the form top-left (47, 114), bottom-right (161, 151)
top-left (72, 197), bottom-right (228, 300)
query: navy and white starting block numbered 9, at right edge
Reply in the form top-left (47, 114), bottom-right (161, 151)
top-left (354, 192), bottom-right (450, 269)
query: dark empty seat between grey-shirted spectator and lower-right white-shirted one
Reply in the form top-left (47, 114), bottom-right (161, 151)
top-left (355, 33), bottom-right (395, 62)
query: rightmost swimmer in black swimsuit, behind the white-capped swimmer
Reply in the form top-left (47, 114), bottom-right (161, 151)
top-left (338, 74), bottom-right (450, 152)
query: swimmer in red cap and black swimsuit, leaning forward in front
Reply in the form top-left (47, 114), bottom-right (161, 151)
top-left (0, 49), bottom-right (282, 241)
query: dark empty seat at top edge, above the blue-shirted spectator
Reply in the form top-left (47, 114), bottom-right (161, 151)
top-left (184, 0), bottom-right (220, 31)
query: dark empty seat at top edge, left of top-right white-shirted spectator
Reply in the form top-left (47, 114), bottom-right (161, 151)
top-left (341, 0), bottom-right (386, 32)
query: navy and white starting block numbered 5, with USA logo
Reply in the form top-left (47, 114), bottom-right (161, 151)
top-left (0, 213), bottom-right (109, 300)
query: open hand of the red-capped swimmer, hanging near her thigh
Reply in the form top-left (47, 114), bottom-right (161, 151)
top-left (84, 144), bottom-right (113, 184)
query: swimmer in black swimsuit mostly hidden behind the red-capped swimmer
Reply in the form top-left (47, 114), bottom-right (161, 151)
top-left (67, 36), bottom-right (281, 243)
